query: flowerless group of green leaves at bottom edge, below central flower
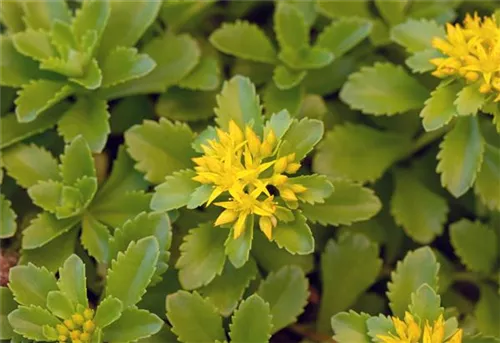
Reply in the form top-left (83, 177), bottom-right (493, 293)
top-left (166, 266), bottom-right (309, 343)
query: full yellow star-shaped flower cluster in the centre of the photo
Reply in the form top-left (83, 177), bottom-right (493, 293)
top-left (193, 121), bottom-right (307, 239)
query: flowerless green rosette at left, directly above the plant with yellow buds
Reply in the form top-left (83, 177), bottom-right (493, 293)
top-left (3, 136), bottom-right (151, 271)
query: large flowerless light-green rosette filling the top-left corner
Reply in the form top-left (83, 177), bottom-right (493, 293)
top-left (0, 0), bottom-right (218, 152)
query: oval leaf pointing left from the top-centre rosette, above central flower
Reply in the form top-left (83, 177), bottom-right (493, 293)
top-left (209, 20), bottom-right (276, 64)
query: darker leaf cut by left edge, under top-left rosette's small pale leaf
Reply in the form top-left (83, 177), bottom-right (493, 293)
top-left (0, 35), bottom-right (43, 87)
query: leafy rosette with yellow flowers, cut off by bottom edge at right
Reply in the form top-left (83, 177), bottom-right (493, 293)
top-left (331, 247), bottom-right (499, 343)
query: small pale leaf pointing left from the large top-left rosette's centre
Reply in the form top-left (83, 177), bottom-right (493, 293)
top-left (12, 29), bottom-right (56, 61)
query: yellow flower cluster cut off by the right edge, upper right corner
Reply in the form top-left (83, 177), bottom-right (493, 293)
top-left (430, 14), bottom-right (500, 101)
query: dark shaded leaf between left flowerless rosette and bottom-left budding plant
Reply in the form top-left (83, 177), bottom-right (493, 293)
top-left (19, 230), bottom-right (78, 274)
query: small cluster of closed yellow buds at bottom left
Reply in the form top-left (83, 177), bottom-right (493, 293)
top-left (56, 308), bottom-right (95, 343)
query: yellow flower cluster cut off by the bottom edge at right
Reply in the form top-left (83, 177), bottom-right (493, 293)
top-left (377, 312), bottom-right (463, 343)
